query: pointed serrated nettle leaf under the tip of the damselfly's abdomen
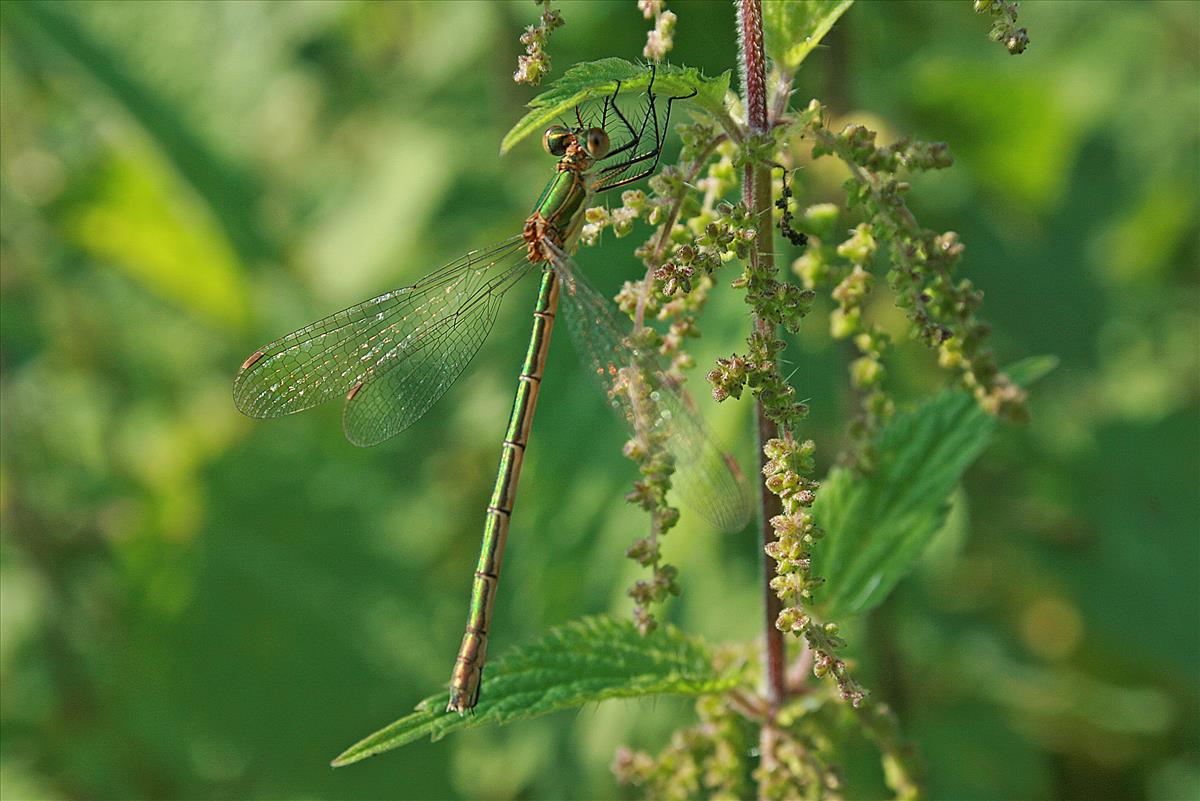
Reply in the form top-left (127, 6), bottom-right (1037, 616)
top-left (332, 618), bottom-right (739, 767)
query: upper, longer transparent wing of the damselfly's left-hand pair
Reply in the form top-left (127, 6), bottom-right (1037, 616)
top-left (233, 236), bottom-right (524, 430)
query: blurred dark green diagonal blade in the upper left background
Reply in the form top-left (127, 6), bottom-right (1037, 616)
top-left (4, 2), bottom-right (272, 261)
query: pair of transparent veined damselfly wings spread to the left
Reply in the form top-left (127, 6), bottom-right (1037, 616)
top-left (233, 231), bottom-right (530, 444)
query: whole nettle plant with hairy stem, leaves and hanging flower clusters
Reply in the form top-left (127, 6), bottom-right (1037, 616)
top-left (334, 0), bottom-right (1052, 799)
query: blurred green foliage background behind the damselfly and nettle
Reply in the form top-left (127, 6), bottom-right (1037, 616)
top-left (0, 0), bottom-right (1200, 801)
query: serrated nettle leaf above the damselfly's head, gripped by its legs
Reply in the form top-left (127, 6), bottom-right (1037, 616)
top-left (500, 59), bottom-right (730, 153)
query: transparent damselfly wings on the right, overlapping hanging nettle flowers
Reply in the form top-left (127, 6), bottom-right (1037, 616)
top-left (552, 242), bottom-right (752, 531)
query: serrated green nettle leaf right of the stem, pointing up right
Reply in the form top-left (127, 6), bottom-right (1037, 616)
top-left (812, 356), bottom-right (1057, 620)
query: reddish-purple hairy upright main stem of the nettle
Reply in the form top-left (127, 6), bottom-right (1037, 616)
top-left (738, 0), bottom-right (787, 797)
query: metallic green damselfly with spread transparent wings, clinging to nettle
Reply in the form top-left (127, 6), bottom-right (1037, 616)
top-left (234, 73), bottom-right (750, 712)
